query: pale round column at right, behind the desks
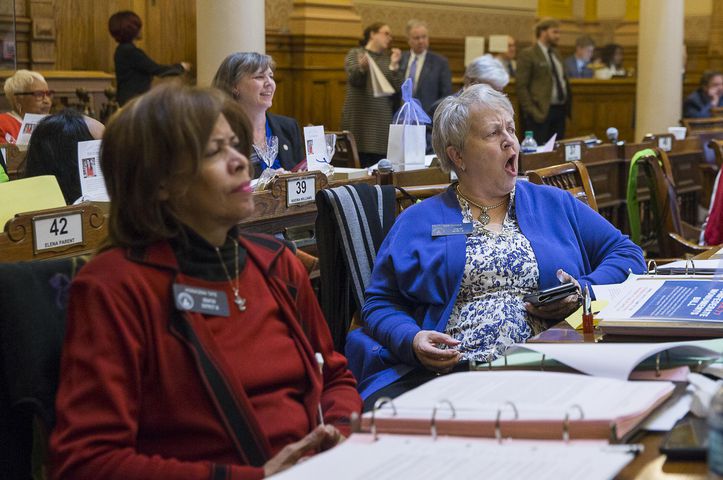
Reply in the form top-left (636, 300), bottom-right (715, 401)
top-left (634, 0), bottom-right (685, 141)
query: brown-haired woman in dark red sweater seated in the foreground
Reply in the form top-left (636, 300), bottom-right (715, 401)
top-left (50, 83), bottom-right (361, 480)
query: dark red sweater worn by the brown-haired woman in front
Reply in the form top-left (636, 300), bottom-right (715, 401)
top-left (51, 236), bottom-right (361, 480)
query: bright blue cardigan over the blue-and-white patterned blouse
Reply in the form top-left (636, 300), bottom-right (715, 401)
top-left (346, 182), bottom-right (645, 398)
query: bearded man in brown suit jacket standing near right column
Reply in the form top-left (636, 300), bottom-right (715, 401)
top-left (516, 18), bottom-right (571, 143)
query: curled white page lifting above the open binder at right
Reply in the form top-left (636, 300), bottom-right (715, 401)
top-left (507, 339), bottom-right (721, 380)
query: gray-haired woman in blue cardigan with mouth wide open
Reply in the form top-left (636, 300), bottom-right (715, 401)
top-left (346, 85), bottom-right (645, 408)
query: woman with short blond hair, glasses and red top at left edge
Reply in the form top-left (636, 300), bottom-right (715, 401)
top-left (0, 70), bottom-right (55, 143)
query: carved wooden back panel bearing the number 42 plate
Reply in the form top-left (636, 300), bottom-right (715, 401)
top-left (0, 203), bottom-right (108, 262)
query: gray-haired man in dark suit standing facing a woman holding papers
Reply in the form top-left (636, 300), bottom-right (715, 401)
top-left (399, 20), bottom-right (452, 116)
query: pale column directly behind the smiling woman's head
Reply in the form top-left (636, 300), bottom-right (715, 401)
top-left (196, 0), bottom-right (266, 86)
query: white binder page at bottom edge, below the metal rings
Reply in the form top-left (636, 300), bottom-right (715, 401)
top-left (273, 435), bottom-right (633, 480)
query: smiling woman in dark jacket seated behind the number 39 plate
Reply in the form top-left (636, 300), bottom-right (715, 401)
top-left (212, 52), bottom-right (305, 177)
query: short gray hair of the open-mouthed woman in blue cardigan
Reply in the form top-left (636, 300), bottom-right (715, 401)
top-left (432, 84), bottom-right (515, 173)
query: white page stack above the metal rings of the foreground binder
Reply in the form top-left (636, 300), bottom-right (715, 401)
top-left (364, 371), bottom-right (673, 420)
